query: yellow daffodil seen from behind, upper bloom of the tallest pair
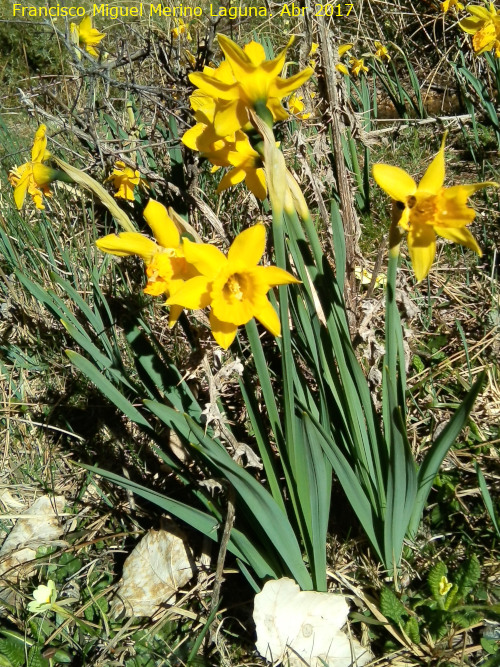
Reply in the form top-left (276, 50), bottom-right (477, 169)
top-left (189, 35), bottom-right (313, 137)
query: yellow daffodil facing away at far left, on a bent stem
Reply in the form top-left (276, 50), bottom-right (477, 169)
top-left (9, 125), bottom-right (60, 211)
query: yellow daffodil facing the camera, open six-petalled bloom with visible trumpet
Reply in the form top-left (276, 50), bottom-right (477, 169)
top-left (167, 224), bottom-right (300, 349)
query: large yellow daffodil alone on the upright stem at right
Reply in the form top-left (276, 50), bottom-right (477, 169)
top-left (373, 134), bottom-right (499, 282)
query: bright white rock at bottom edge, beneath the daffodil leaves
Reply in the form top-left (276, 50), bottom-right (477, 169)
top-left (253, 578), bottom-right (372, 667)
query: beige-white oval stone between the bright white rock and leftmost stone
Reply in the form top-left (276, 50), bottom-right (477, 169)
top-left (111, 522), bottom-right (195, 616)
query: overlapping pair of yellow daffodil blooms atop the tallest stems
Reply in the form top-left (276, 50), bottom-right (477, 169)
top-left (182, 35), bottom-right (313, 199)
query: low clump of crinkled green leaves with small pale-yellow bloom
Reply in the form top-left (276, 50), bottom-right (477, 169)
top-left (380, 555), bottom-right (486, 644)
